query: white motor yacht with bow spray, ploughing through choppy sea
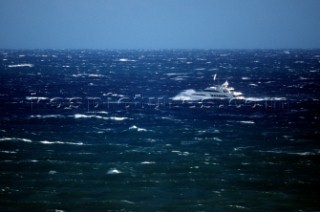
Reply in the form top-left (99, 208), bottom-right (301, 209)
top-left (173, 78), bottom-right (244, 101)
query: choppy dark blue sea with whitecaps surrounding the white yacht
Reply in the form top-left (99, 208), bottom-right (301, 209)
top-left (0, 50), bottom-right (320, 211)
